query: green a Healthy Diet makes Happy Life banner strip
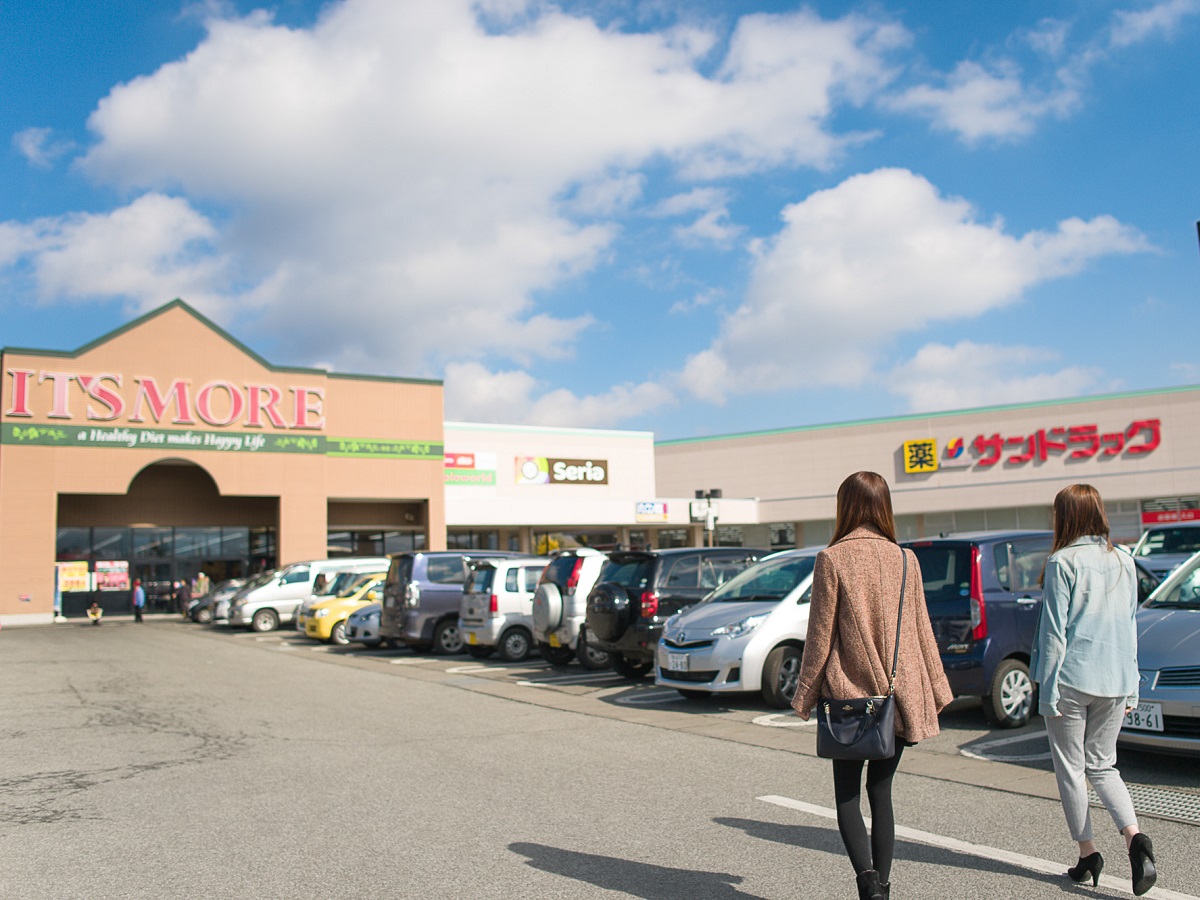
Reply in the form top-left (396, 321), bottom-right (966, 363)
top-left (0, 422), bottom-right (442, 460)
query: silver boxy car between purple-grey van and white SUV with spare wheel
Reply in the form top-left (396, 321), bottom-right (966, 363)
top-left (458, 557), bottom-right (550, 662)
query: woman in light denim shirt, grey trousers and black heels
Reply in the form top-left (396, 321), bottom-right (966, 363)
top-left (1030, 485), bottom-right (1158, 896)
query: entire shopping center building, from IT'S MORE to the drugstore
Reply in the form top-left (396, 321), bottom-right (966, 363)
top-left (0, 300), bottom-right (1200, 625)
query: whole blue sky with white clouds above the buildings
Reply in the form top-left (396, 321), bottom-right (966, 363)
top-left (0, 0), bottom-right (1200, 438)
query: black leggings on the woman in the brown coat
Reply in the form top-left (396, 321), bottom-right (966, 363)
top-left (833, 740), bottom-right (904, 881)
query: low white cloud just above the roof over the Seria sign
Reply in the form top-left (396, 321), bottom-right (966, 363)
top-left (445, 362), bottom-right (676, 427)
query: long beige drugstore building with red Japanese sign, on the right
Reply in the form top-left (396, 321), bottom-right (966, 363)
top-left (655, 388), bottom-right (1200, 554)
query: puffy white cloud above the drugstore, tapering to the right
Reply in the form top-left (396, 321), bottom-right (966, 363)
top-left (680, 169), bottom-right (1150, 402)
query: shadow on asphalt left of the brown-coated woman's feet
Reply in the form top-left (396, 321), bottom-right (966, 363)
top-left (509, 844), bottom-right (755, 900)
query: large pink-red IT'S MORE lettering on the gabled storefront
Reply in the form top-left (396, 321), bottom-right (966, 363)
top-left (5, 368), bottom-right (325, 431)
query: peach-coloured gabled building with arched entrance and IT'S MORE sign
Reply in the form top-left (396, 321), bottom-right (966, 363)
top-left (0, 300), bottom-right (446, 624)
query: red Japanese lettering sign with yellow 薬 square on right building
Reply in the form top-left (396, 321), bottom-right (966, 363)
top-left (902, 419), bottom-right (1163, 474)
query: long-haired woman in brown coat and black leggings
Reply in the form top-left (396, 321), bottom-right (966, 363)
top-left (792, 472), bottom-right (954, 900)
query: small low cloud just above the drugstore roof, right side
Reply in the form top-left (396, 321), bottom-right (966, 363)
top-left (884, 341), bottom-right (1103, 412)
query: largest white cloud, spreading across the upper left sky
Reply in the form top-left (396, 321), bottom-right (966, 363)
top-left (11, 0), bottom-right (907, 374)
